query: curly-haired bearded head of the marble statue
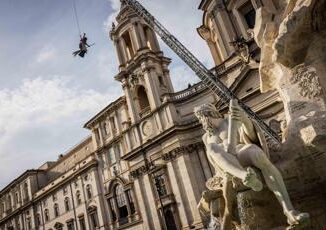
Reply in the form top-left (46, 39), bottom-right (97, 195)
top-left (194, 104), bottom-right (223, 134)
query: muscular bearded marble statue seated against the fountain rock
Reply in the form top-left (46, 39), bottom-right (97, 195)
top-left (194, 101), bottom-right (309, 226)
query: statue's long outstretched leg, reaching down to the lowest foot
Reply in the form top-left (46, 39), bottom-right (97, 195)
top-left (239, 145), bottom-right (309, 225)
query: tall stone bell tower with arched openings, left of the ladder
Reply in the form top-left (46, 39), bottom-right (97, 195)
top-left (110, 3), bottom-right (174, 122)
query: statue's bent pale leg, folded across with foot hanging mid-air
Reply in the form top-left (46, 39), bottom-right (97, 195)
top-left (206, 144), bottom-right (263, 191)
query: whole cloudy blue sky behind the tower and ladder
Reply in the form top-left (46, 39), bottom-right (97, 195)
top-left (0, 0), bottom-right (212, 188)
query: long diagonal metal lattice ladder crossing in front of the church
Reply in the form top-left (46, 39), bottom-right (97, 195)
top-left (121, 0), bottom-right (280, 144)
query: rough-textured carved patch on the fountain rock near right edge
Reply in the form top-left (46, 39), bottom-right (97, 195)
top-left (291, 64), bottom-right (322, 99)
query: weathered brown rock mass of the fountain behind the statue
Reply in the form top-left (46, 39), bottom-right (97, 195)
top-left (254, 0), bottom-right (326, 229)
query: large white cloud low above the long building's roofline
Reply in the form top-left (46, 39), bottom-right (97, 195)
top-left (0, 76), bottom-right (109, 185)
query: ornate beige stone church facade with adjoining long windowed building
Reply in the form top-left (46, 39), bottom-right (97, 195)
top-left (0, 0), bottom-right (285, 230)
